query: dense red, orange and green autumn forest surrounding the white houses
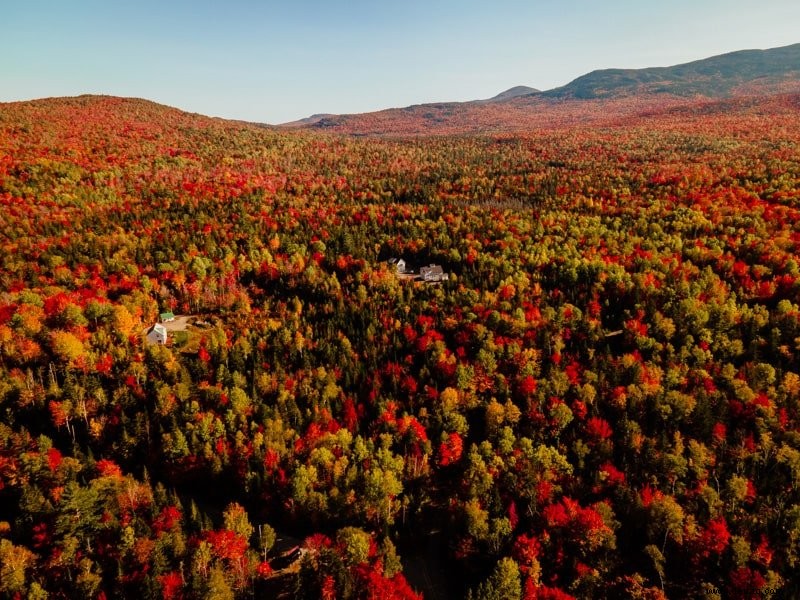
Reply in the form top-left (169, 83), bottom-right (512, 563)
top-left (0, 95), bottom-right (800, 600)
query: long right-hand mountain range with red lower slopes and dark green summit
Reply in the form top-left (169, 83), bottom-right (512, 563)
top-left (282, 44), bottom-right (800, 135)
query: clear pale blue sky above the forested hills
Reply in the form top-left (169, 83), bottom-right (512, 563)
top-left (0, 0), bottom-right (800, 123)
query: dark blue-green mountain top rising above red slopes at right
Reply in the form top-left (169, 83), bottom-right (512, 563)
top-left (543, 44), bottom-right (800, 99)
